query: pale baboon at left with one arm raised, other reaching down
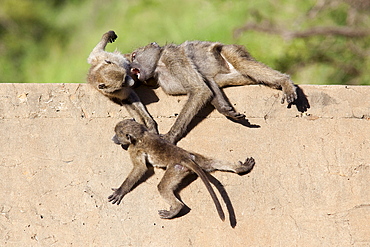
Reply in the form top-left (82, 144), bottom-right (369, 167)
top-left (87, 31), bottom-right (158, 133)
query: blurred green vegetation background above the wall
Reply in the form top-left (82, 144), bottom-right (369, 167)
top-left (0, 0), bottom-right (370, 85)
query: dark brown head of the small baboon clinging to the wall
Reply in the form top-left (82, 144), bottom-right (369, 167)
top-left (112, 119), bottom-right (147, 150)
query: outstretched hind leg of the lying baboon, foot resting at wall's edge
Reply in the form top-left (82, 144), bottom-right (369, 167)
top-left (221, 45), bottom-right (297, 103)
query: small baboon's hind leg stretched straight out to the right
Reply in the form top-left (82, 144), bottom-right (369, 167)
top-left (192, 153), bottom-right (255, 174)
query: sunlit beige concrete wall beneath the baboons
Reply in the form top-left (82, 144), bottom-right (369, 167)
top-left (0, 84), bottom-right (370, 247)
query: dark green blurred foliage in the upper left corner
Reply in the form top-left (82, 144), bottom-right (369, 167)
top-left (0, 0), bottom-right (83, 82)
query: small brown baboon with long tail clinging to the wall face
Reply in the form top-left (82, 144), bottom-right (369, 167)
top-left (108, 119), bottom-right (255, 220)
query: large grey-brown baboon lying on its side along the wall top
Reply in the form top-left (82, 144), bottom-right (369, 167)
top-left (130, 41), bottom-right (297, 143)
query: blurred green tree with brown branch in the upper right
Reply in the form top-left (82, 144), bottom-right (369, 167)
top-left (234, 0), bottom-right (370, 84)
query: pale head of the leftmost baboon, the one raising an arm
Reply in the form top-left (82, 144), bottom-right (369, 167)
top-left (89, 60), bottom-right (134, 95)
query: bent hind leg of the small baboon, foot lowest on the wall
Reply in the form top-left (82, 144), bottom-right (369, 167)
top-left (158, 164), bottom-right (191, 219)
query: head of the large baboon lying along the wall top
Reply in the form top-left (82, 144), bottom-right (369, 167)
top-left (130, 42), bottom-right (161, 81)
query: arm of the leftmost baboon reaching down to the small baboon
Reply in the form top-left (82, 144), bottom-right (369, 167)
top-left (123, 91), bottom-right (158, 134)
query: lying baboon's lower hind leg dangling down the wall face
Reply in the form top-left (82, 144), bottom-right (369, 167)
top-left (208, 80), bottom-right (245, 119)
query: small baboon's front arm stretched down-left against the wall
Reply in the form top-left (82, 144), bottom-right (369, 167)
top-left (108, 154), bottom-right (148, 205)
